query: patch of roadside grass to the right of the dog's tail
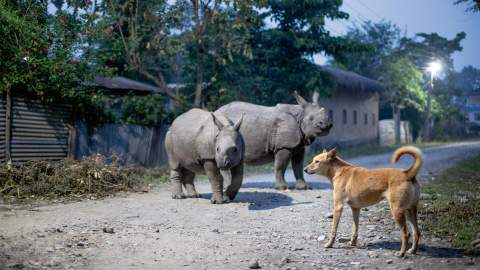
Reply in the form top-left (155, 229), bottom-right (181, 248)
top-left (420, 155), bottom-right (480, 253)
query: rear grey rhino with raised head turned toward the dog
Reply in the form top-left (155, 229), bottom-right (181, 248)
top-left (216, 93), bottom-right (332, 190)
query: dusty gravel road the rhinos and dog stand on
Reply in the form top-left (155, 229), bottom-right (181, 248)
top-left (0, 142), bottom-right (480, 270)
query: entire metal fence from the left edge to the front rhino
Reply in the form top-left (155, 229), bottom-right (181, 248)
top-left (0, 97), bottom-right (167, 166)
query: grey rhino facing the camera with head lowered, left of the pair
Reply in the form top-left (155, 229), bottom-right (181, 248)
top-left (165, 109), bottom-right (245, 203)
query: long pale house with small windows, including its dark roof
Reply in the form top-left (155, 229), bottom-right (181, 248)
top-left (313, 67), bottom-right (383, 149)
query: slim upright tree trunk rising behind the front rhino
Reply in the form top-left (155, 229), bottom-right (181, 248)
top-left (193, 0), bottom-right (205, 108)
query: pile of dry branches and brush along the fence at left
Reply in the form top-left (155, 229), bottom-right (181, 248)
top-left (0, 155), bottom-right (145, 198)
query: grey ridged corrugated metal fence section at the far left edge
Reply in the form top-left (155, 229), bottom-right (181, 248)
top-left (0, 97), bottom-right (71, 164)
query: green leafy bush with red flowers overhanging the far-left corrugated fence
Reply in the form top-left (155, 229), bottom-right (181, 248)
top-left (0, 0), bottom-right (112, 126)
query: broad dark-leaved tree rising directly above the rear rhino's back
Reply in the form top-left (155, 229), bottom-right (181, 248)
top-left (204, 0), bottom-right (357, 107)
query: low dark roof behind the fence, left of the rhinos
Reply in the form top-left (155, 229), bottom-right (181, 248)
top-left (93, 76), bottom-right (160, 92)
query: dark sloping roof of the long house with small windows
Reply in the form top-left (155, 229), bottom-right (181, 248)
top-left (320, 66), bottom-right (383, 92)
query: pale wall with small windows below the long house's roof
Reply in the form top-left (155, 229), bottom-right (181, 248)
top-left (314, 91), bottom-right (379, 148)
